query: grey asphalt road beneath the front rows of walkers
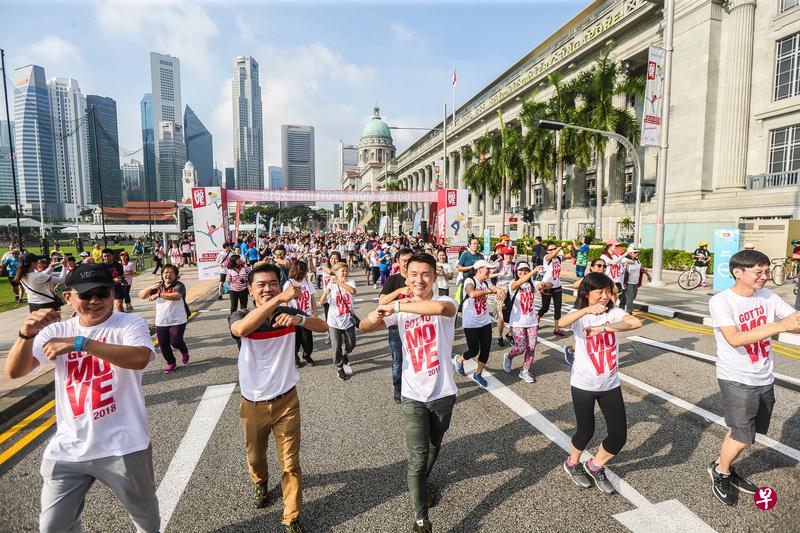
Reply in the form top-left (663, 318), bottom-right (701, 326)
top-left (0, 276), bottom-right (800, 532)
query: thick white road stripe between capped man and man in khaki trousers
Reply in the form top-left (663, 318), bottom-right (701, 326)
top-left (156, 383), bottom-right (236, 531)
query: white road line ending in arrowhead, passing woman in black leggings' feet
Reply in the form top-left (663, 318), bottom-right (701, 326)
top-left (464, 360), bottom-right (714, 533)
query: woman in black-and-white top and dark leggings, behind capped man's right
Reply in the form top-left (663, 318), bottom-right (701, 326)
top-left (139, 265), bottom-right (189, 374)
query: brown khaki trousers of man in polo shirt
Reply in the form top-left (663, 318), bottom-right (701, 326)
top-left (239, 389), bottom-right (303, 524)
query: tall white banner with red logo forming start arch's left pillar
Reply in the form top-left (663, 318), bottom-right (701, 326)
top-left (192, 187), bottom-right (225, 279)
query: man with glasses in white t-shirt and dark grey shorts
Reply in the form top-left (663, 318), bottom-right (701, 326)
top-left (708, 250), bottom-right (800, 505)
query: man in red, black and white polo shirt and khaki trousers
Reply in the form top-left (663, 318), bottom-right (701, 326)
top-left (228, 263), bottom-right (328, 533)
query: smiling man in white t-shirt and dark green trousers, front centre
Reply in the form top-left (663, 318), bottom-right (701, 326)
top-left (360, 253), bottom-right (458, 533)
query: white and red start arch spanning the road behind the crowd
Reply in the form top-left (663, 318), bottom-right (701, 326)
top-left (187, 187), bottom-right (469, 279)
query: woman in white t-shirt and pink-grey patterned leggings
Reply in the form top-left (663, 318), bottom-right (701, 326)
top-left (503, 261), bottom-right (549, 383)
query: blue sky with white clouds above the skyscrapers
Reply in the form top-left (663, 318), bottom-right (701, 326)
top-left (0, 0), bottom-right (589, 189)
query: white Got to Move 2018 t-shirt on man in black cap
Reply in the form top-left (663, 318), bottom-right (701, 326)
top-left (33, 312), bottom-right (155, 462)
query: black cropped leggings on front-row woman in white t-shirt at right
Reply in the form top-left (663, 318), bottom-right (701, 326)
top-left (570, 387), bottom-right (628, 455)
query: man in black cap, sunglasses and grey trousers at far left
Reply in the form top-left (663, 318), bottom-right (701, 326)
top-left (6, 264), bottom-right (161, 532)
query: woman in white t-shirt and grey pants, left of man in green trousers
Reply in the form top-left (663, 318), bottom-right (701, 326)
top-left (322, 261), bottom-right (358, 381)
